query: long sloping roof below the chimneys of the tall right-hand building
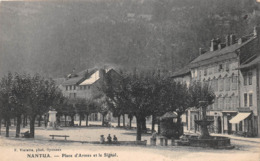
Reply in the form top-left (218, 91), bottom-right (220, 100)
top-left (190, 37), bottom-right (256, 67)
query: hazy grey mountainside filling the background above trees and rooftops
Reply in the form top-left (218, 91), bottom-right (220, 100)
top-left (0, 0), bottom-right (260, 77)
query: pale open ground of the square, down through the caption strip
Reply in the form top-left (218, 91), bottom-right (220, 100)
top-left (0, 122), bottom-right (260, 161)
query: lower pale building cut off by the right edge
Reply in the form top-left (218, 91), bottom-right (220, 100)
top-left (238, 55), bottom-right (260, 136)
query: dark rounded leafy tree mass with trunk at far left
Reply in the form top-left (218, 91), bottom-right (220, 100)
top-left (0, 73), bottom-right (63, 137)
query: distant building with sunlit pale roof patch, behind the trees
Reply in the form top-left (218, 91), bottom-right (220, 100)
top-left (56, 68), bottom-right (121, 121)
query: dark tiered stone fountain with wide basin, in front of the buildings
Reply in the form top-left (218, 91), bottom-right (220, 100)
top-left (189, 101), bottom-right (234, 149)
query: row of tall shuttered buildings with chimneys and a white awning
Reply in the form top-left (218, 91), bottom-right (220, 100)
top-left (173, 27), bottom-right (260, 135)
